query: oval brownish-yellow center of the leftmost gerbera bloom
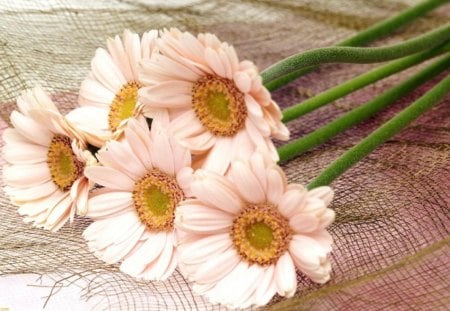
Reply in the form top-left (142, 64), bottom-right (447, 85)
top-left (47, 134), bottom-right (84, 191)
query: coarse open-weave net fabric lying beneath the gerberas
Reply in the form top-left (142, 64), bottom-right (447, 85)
top-left (0, 0), bottom-right (450, 311)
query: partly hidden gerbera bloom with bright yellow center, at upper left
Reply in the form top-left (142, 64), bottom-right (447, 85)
top-left (67, 30), bottom-right (158, 147)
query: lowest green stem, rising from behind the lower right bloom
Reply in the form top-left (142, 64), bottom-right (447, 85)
top-left (308, 70), bottom-right (450, 189)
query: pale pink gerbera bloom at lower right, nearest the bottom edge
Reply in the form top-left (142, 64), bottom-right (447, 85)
top-left (175, 153), bottom-right (334, 308)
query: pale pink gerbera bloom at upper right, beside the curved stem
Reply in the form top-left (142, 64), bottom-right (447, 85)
top-left (139, 29), bottom-right (289, 174)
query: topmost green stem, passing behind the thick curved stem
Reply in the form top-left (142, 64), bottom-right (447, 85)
top-left (265, 0), bottom-right (450, 91)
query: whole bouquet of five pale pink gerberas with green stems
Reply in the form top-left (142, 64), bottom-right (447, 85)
top-left (3, 1), bottom-right (450, 308)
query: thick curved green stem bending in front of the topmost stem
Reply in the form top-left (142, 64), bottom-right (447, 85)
top-left (261, 23), bottom-right (450, 83)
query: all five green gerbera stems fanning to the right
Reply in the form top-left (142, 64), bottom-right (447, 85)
top-left (268, 0), bottom-right (450, 189)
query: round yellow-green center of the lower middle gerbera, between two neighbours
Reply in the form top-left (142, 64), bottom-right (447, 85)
top-left (133, 169), bottom-right (184, 231)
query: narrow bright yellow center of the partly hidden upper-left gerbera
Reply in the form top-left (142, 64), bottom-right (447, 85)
top-left (108, 81), bottom-right (141, 131)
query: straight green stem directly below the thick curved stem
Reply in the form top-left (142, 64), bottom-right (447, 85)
top-left (283, 42), bottom-right (450, 122)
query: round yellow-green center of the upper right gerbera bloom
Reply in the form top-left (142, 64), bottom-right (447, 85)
top-left (192, 76), bottom-right (247, 136)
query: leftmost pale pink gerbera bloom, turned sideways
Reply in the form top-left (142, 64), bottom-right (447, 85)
top-left (3, 88), bottom-right (97, 231)
